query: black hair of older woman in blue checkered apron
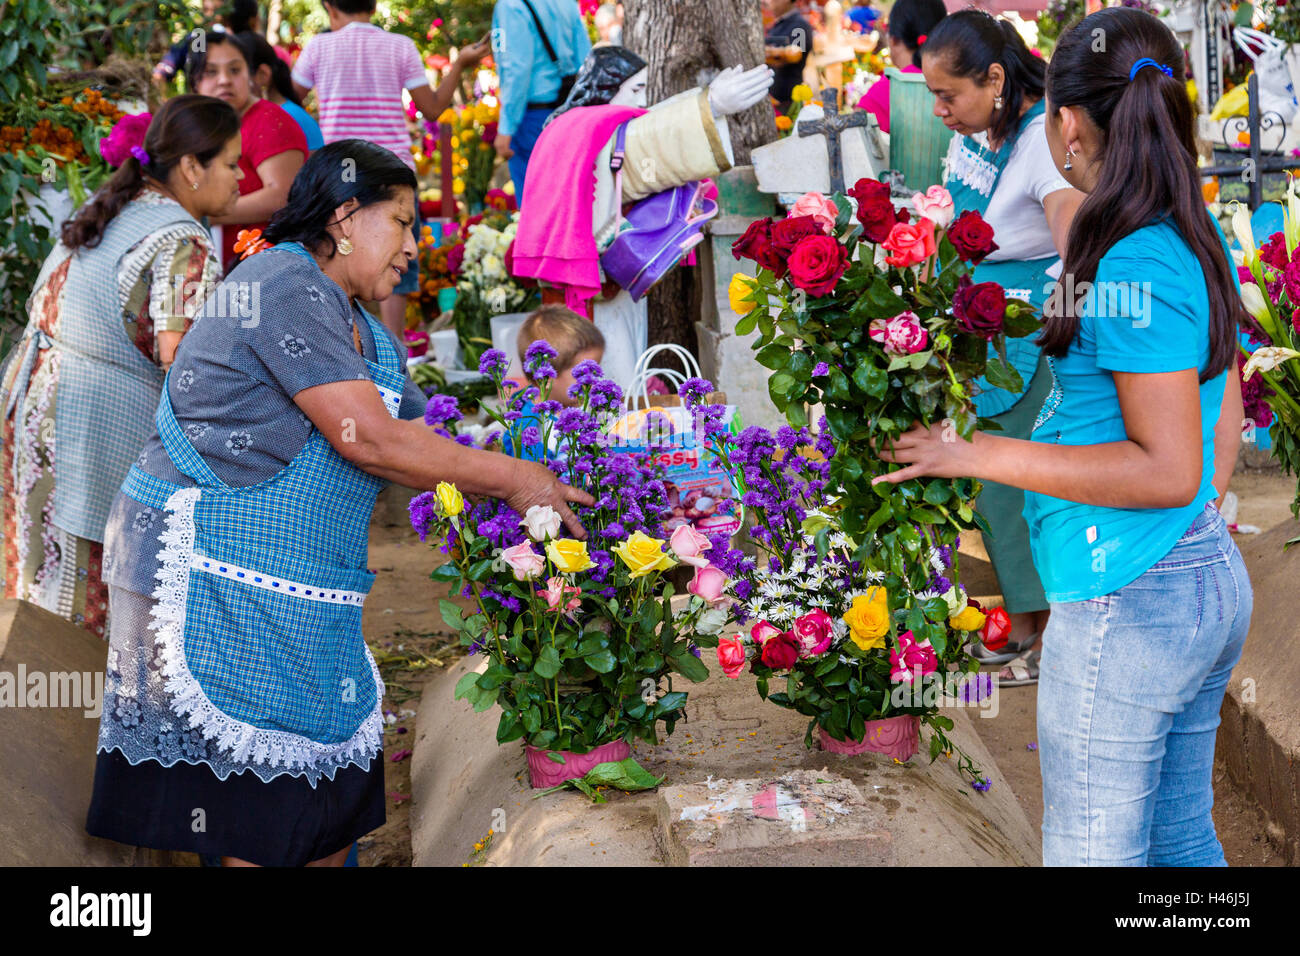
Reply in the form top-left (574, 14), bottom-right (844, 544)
top-left (265, 139), bottom-right (417, 256)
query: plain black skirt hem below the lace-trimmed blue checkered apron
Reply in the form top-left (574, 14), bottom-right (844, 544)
top-left (86, 750), bottom-right (386, 866)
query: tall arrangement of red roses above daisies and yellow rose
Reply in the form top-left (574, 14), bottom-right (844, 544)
top-left (716, 179), bottom-right (1040, 780)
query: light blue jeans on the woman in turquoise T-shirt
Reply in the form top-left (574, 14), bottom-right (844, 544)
top-left (1037, 505), bottom-right (1253, 866)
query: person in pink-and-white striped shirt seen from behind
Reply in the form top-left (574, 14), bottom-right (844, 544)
top-left (293, 0), bottom-right (489, 336)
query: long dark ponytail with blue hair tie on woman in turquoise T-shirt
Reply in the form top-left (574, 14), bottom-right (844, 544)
top-left (1037, 7), bottom-right (1244, 382)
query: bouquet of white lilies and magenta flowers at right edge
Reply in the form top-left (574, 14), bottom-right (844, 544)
top-left (1232, 200), bottom-right (1300, 546)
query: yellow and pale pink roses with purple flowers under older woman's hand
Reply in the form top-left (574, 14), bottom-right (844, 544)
top-left (411, 342), bottom-right (727, 787)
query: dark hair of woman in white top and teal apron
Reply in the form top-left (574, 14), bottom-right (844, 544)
top-left (924, 10), bottom-right (1047, 140)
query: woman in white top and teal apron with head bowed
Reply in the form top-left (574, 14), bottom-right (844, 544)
top-left (923, 10), bottom-right (1083, 684)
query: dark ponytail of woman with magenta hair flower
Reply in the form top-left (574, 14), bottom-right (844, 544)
top-left (60, 94), bottom-right (239, 250)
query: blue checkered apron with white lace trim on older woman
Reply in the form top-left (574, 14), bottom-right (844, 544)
top-left (122, 290), bottom-right (404, 769)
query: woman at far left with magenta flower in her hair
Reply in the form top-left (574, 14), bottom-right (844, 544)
top-left (0, 96), bottom-right (239, 637)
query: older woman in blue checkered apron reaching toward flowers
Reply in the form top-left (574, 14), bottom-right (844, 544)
top-left (87, 139), bottom-right (590, 865)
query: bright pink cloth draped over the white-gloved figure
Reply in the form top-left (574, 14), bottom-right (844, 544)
top-left (514, 105), bottom-right (646, 315)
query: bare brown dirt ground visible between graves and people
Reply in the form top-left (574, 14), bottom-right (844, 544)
top-left (359, 466), bottom-right (1296, 866)
